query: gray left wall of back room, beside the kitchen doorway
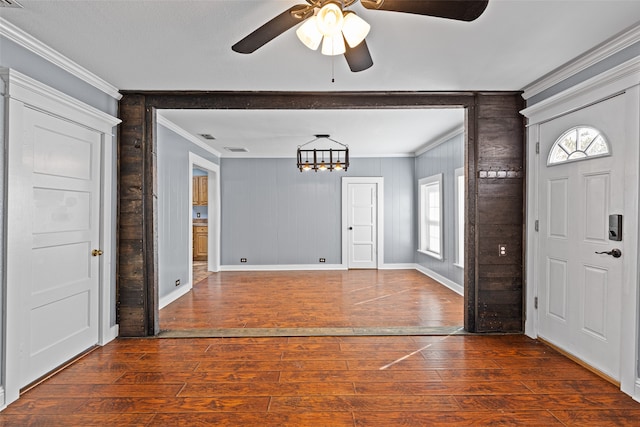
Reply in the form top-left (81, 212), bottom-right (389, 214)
top-left (157, 125), bottom-right (219, 298)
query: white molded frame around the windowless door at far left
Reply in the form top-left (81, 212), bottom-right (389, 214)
top-left (0, 68), bottom-right (120, 409)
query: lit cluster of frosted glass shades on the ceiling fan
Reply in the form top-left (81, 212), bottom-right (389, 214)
top-left (296, 0), bottom-right (371, 56)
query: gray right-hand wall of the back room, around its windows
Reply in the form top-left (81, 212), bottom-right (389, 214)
top-left (414, 134), bottom-right (464, 285)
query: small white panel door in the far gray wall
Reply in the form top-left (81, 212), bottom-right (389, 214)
top-left (347, 183), bottom-right (378, 268)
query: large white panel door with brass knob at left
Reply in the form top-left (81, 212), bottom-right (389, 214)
top-left (17, 108), bottom-right (101, 386)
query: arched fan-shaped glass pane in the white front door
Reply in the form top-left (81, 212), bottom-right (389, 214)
top-left (547, 126), bottom-right (611, 166)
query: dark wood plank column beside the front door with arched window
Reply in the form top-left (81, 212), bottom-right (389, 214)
top-left (469, 93), bottom-right (525, 332)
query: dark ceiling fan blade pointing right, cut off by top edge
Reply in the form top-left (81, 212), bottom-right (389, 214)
top-left (360, 0), bottom-right (489, 21)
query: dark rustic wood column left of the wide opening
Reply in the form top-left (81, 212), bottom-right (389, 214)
top-left (117, 95), bottom-right (159, 337)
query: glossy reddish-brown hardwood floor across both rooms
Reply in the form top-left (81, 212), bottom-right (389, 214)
top-left (0, 271), bottom-right (640, 427)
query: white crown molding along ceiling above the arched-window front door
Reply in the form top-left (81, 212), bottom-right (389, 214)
top-left (522, 25), bottom-right (640, 99)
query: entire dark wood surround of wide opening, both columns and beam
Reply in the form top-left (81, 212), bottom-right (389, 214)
top-left (117, 92), bottom-right (525, 336)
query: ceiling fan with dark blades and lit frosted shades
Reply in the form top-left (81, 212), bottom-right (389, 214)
top-left (231, 0), bottom-right (489, 72)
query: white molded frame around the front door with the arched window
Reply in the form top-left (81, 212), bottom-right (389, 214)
top-left (522, 58), bottom-right (640, 401)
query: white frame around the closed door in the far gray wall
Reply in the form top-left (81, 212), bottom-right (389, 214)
top-left (341, 176), bottom-right (384, 269)
